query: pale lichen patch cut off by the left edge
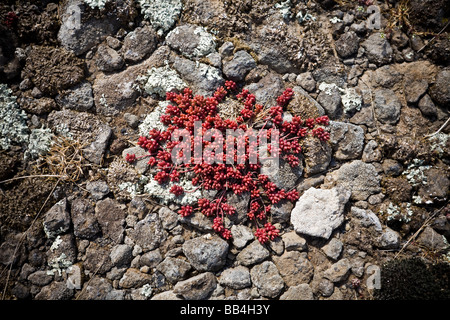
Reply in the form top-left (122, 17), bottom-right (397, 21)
top-left (0, 84), bottom-right (30, 150)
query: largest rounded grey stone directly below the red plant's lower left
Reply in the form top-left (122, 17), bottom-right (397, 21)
top-left (183, 234), bottom-right (229, 271)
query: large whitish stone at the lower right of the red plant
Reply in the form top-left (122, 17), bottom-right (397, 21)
top-left (291, 188), bottom-right (351, 239)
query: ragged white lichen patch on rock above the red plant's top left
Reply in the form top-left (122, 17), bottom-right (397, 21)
top-left (142, 65), bottom-right (188, 98)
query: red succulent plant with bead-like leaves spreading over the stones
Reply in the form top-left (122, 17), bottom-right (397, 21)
top-left (126, 81), bottom-right (330, 243)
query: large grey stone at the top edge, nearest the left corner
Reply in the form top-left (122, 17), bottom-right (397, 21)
top-left (58, 0), bottom-right (120, 55)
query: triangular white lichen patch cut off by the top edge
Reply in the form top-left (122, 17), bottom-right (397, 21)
top-left (137, 0), bottom-right (183, 35)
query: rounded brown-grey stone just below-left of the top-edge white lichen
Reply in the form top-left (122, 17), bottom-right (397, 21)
top-left (122, 26), bottom-right (157, 63)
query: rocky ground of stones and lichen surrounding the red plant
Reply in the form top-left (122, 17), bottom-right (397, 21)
top-left (0, 0), bottom-right (450, 300)
